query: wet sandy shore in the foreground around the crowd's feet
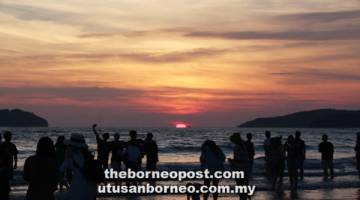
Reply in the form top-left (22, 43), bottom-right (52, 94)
top-left (11, 165), bottom-right (360, 200)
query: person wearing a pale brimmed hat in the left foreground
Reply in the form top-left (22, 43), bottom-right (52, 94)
top-left (61, 133), bottom-right (97, 200)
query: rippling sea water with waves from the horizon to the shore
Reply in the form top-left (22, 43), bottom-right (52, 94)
top-left (4, 127), bottom-right (360, 199)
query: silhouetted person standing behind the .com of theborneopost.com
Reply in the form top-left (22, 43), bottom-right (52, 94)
top-left (228, 133), bottom-right (249, 200)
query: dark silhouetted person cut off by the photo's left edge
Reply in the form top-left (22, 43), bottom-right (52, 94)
top-left (0, 141), bottom-right (12, 200)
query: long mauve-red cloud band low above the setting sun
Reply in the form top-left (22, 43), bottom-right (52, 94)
top-left (0, 87), bottom-right (296, 114)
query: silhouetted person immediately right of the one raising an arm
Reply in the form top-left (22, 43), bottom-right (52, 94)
top-left (110, 133), bottom-right (126, 171)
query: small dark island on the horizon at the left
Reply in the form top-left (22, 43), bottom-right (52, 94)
top-left (0, 109), bottom-right (48, 127)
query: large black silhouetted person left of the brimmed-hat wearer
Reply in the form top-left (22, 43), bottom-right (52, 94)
top-left (23, 137), bottom-right (59, 200)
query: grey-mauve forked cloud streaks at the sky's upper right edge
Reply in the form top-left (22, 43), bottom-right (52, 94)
top-left (184, 10), bottom-right (360, 41)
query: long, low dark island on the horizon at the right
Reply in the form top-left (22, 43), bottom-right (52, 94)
top-left (238, 109), bottom-right (360, 128)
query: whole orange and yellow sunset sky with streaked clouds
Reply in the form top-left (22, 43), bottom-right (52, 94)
top-left (0, 0), bottom-right (360, 126)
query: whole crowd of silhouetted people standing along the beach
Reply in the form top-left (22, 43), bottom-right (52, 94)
top-left (0, 127), bottom-right (360, 200)
